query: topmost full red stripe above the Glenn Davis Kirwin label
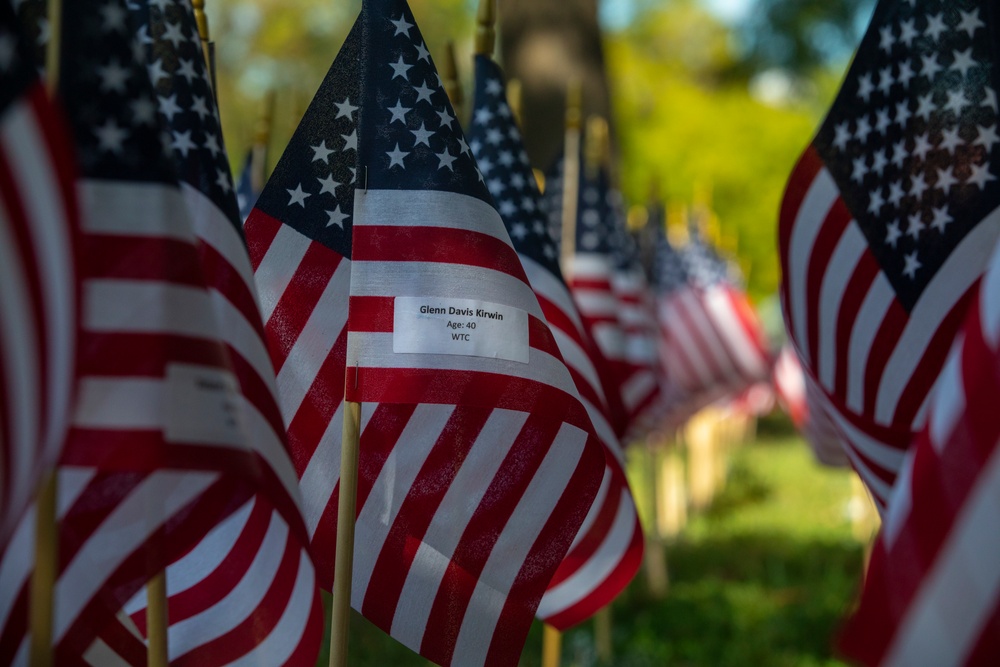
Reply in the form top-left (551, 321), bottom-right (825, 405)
top-left (351, 225), bottom-right (527, 282)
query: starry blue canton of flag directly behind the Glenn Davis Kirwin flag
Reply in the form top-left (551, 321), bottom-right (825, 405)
top-left (469, 55), bottom-right (562, 280)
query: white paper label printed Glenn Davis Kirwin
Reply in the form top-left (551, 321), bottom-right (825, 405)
top-left (392, 296), bottom-right (528, 364)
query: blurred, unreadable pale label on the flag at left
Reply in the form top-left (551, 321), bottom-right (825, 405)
top-left (164, 364), bottom-right (242, 444)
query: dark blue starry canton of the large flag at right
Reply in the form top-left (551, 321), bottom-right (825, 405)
top-left (814, 0), bottom-right (1000, 311)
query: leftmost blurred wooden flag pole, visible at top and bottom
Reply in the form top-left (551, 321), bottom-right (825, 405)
top-left (28, 5), bottom-right (62, 667)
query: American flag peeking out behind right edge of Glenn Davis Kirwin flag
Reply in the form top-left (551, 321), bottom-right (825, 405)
top-left (469, 55), bottom-right (643, 630)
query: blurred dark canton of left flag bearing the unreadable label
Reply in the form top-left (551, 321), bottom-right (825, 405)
top-left (59, 0), bottom-right (176, 183)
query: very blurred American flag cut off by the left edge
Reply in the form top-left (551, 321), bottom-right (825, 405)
top-left (0, 4), bottom-right (79, 544)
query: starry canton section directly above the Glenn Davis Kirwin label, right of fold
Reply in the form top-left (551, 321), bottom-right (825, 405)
top-left (358, 0), bottom-right (493, 205)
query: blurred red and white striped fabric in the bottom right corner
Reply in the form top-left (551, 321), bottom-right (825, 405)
top-left (840, 232), bottom-right (1000, 666)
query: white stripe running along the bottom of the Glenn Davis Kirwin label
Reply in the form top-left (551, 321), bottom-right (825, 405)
top-left (347, 331), bottom-right (577, 397)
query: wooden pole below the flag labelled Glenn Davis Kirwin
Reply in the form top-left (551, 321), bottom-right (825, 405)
top-left (330, 401), bottom-right (361, 667)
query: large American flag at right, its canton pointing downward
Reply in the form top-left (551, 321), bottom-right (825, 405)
top-left (779, 0), bottom-right (1000, 509)
